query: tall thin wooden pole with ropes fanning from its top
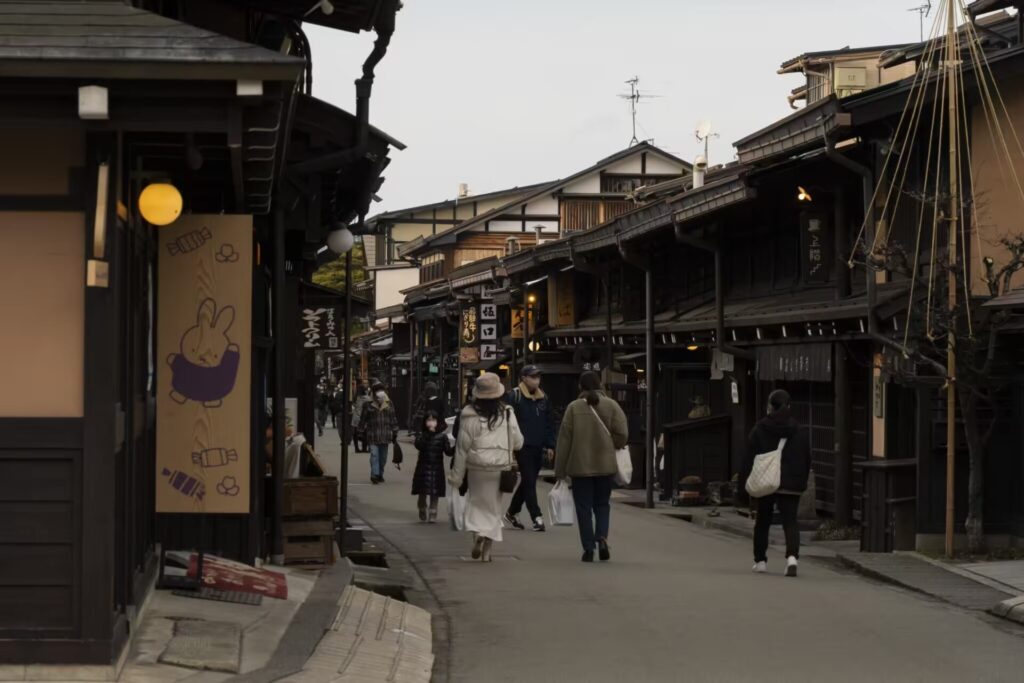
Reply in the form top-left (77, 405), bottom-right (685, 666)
top-left (945, 0), bottom-right (959, 558)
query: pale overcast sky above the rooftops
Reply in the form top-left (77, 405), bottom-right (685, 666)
top-left (307, 0), bottom-right (934, 213)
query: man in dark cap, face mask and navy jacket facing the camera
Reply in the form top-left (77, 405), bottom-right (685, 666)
top-left (505, 366), bottom-right (555, 531)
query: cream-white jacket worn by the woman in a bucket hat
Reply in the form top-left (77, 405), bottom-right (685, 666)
top-left (449, 405), bottom-right (522, 486)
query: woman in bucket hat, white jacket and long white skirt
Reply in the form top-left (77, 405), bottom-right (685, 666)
top-left (449, 373), bottom-right (522, 562)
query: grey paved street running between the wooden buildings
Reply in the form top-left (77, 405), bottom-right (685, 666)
top-left (318, 431), bottom-right (1024, 682)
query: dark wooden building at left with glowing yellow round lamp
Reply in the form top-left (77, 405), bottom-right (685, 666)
top-left (0, 0), bottom-right (400, 677)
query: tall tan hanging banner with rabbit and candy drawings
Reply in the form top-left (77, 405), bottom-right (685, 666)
top-left (157, 215), bottom-right (252, 514)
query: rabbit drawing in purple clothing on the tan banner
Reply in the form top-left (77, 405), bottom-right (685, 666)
top-left (167, 299), bottom-right (241, 408)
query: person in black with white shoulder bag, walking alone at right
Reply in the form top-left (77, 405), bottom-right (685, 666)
top-left (742, 389), bottom-right (811, 577)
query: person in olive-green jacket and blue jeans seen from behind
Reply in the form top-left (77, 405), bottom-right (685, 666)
top-left (555, 371), bottom-right (629, 562)
